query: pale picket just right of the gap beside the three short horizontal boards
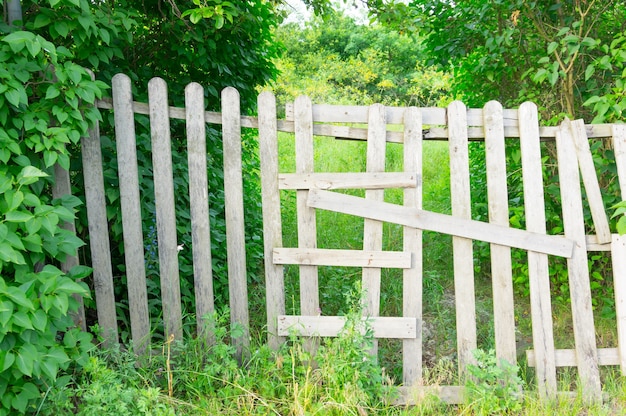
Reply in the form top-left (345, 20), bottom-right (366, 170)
top-left (448, 101), bottom-right (477, 379)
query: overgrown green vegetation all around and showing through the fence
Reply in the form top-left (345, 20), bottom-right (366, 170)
top-left (0, 0), bottom-right (626, 415)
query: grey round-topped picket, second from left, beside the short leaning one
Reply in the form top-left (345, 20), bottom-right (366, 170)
top-left (112, 74), bottom-right (150, 353)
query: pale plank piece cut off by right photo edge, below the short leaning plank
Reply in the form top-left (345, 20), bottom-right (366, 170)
top-left (611, 234), bottom-right (626, 375)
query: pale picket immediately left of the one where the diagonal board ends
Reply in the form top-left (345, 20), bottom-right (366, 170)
top-left (519, 102), bottom-right (557, 399)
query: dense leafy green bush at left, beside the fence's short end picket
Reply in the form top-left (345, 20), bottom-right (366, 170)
top-left (0, 5), bottom-right (113, 414)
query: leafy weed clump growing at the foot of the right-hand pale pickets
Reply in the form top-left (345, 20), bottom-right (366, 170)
top-left (465, 350), bottom-right (524, 415)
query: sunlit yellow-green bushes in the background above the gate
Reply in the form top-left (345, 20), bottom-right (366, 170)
top-left (274, 12), bottom-right (450, 106)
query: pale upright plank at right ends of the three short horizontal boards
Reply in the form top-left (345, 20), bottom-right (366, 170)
top-left (402, 107), bottom-right (423, 386)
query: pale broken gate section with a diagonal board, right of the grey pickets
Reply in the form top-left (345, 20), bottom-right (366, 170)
top-left (259, 93), bottom-right (626, 403)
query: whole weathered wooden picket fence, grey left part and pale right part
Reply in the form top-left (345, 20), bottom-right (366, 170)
top-left (57, 75), bottom-right (626, 403)
